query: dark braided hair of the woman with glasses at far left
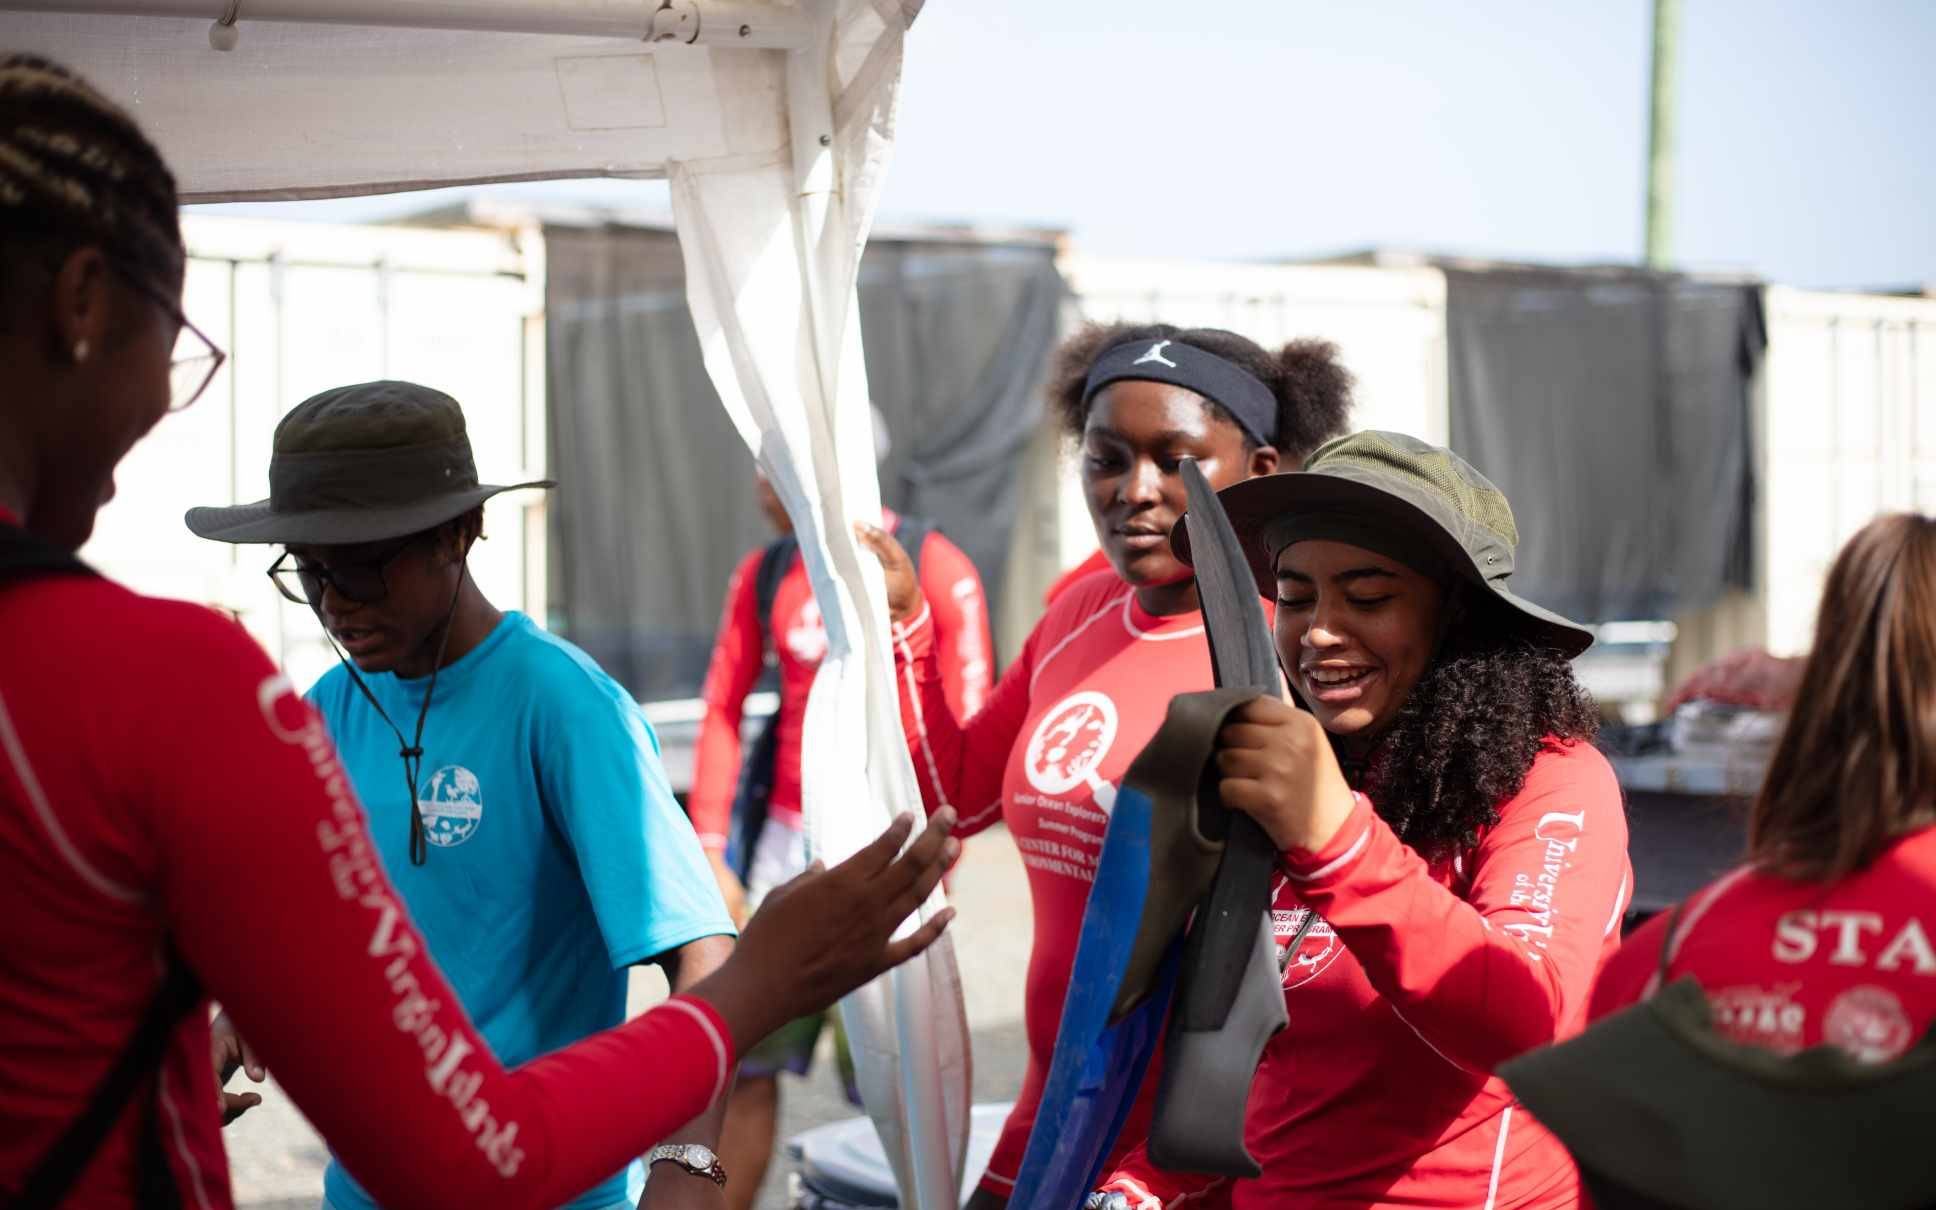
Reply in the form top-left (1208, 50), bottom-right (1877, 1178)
top-left (0, 54), bottom-right (186, 323)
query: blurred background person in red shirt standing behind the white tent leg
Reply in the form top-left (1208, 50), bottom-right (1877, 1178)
top-left (687, 454), bottom-right (993, 1210)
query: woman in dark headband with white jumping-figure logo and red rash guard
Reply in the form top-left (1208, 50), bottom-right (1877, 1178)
top-left (862, 323), bottom-right (1351, 1210)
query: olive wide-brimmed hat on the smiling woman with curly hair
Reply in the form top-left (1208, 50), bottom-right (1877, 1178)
top-left (1169, 430), bottom-right (1593, 658)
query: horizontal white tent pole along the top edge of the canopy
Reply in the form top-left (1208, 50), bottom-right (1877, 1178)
top-left (0, 0), bottom-right (813, 50)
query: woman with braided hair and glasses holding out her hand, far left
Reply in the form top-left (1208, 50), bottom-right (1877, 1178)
top-left (0, 56), bottom-right (956, 1210)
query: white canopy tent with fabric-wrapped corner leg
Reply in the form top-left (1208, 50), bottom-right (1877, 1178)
top-left (0, 0), bottom-right (970, 1210)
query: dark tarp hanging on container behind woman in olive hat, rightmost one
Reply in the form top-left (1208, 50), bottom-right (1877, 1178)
top-left (1446, 269), bottom-right (1768, 623)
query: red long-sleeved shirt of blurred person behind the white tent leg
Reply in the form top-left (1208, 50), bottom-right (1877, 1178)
top-left (687, 513), bottom-right (993, 852)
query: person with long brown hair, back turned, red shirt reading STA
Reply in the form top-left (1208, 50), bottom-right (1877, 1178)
top-left (1593, 513), bottom-right (1936, 1063)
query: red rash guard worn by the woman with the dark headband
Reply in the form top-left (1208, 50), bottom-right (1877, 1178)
top-left (894, 571), bottom-right (1210, 1195)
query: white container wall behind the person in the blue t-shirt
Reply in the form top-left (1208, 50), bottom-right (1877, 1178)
top-left (81, 215), bottom-right (546, 687)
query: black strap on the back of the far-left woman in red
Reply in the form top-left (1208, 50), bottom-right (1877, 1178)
top-left (10, 947), bottom-right (201, 1210)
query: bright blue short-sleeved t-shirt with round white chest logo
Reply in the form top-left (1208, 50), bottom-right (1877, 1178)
top-left (310, 614), bottom-right (734, 1210)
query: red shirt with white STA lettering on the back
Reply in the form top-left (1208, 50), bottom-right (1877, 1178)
top-left (1593, 827), bottom-right (1936, 1063)
